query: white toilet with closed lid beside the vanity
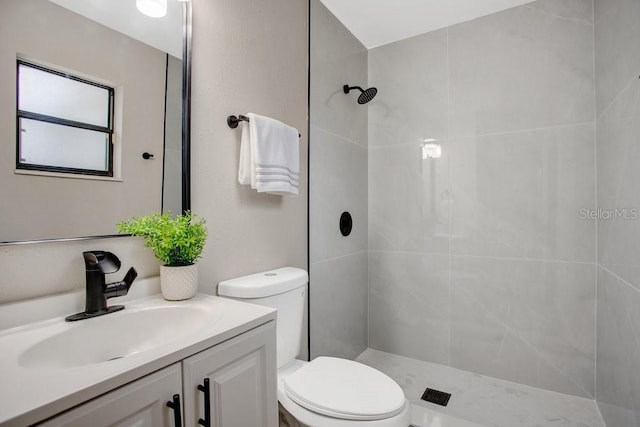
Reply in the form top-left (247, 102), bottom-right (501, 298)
top-left (218, 267), bottom-right (411, 427)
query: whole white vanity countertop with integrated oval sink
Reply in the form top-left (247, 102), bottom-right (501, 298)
top-left (0, 290), bottom-right (276, 426)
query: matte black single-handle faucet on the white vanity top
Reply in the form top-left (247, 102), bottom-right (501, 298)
top-left (65, 251), bottom-right (138, 322)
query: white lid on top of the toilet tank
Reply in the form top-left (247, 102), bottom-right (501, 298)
top-left (218, 267), bottom-right (309, 298)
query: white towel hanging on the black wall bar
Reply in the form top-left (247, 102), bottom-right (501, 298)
top-left (238, 113), bottom-right (300, 195)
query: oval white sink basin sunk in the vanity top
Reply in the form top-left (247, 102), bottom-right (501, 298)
top-left (18, 305), bottom-right (215, 369)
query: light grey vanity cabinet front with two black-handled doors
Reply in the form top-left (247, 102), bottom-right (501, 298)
top-left (39, 321), bottom-right (278, 427)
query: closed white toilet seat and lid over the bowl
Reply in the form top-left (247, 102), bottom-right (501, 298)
top-left (282, 357), bottom-right (406, 421)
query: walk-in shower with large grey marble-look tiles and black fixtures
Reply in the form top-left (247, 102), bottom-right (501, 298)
top-left (309, 0), bottom-right (640, 427)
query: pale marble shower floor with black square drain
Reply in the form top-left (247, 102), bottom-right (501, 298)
top-left (356, 349), bottom-right (605, 427)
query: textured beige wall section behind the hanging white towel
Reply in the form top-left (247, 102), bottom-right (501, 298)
top-left (191, 0), bottom-right (308, 292)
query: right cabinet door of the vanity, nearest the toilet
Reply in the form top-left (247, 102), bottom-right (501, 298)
top-left (182, 321), bottom-right (278, 427)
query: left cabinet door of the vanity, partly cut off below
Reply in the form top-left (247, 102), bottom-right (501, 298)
top-left (41, 363), bottom-right (182, 427)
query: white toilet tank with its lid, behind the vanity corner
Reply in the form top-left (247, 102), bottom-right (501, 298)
top-left (218, 267), bottom-right (309, 368)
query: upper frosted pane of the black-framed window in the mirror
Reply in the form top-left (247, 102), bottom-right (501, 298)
top-left (18, 64), bottom-right (110, 127)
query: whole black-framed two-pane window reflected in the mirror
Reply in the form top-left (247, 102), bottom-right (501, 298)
top-left (16, 60), bottom-right (114, 176)
